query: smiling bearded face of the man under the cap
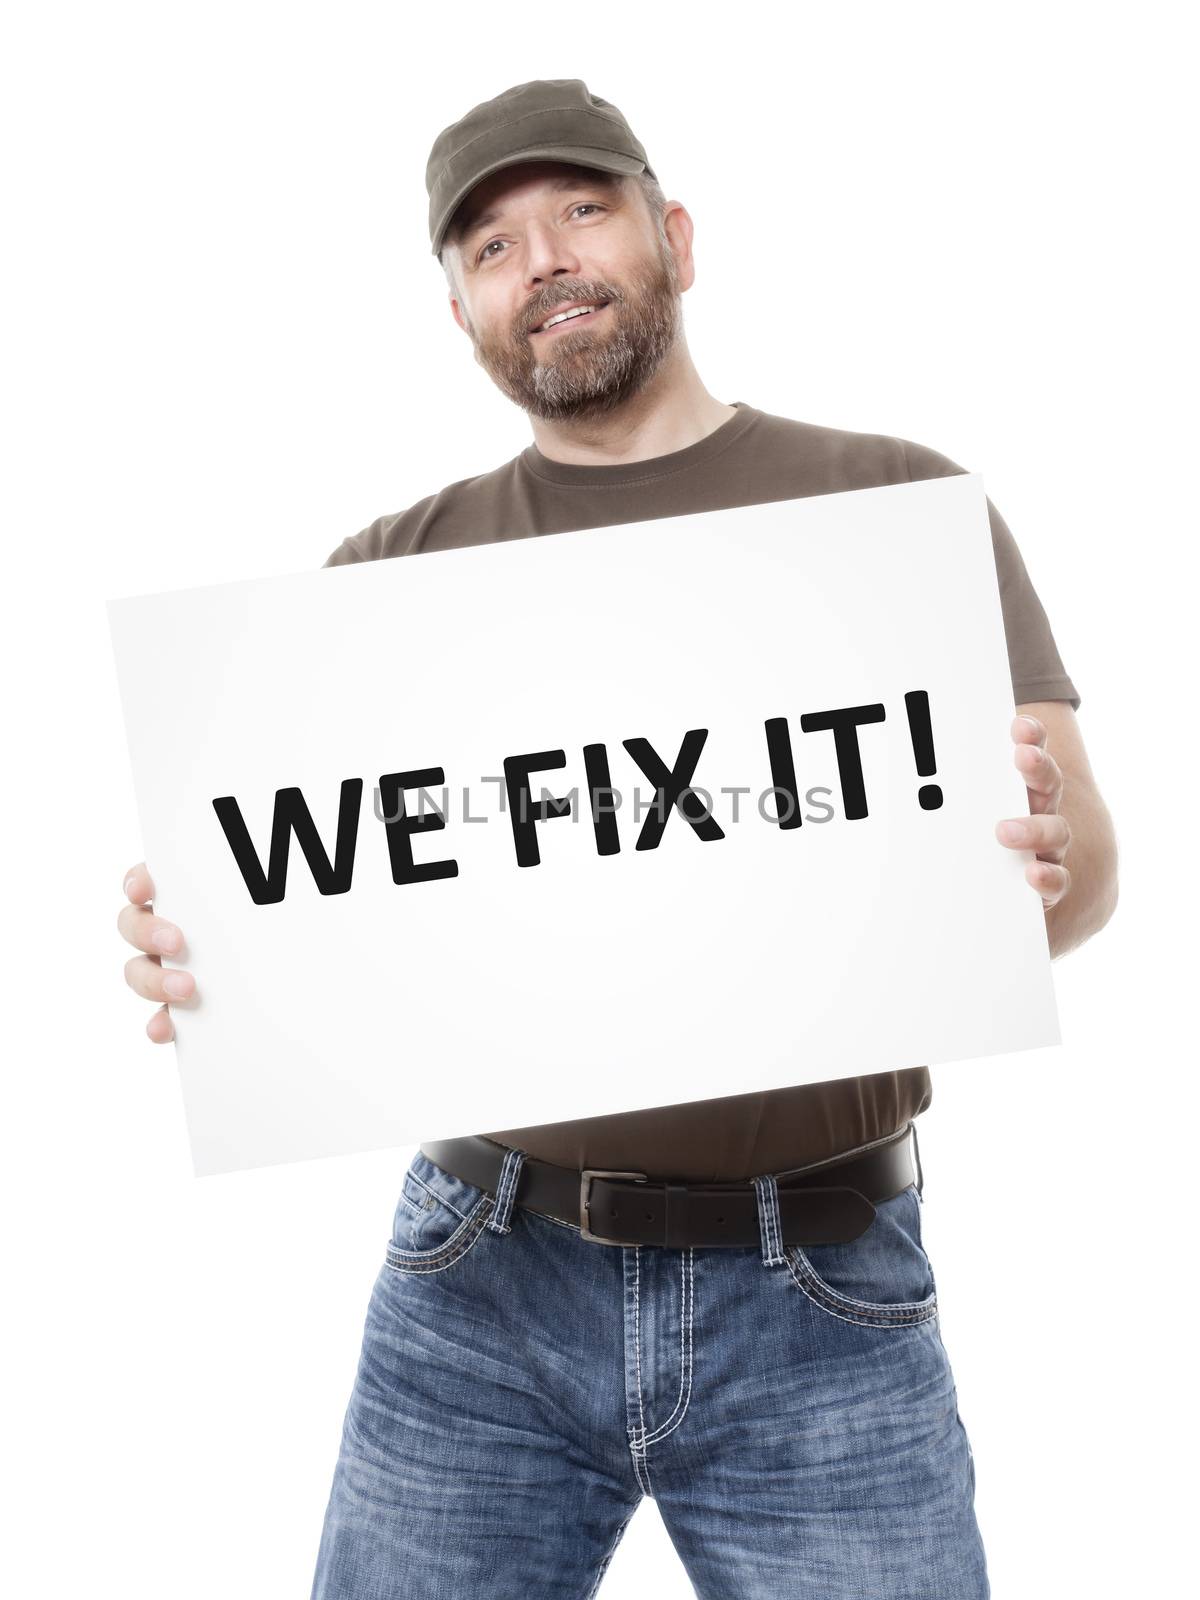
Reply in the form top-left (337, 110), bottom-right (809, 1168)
top-left (445, 162), bottom-right (691, 421)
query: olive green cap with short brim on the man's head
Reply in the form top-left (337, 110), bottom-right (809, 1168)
top-left (426, 78), bottom-right (654, 254)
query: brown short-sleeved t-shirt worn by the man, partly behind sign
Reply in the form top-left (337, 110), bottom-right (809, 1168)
top-left (325, 400), bottom-right (1080, 1182)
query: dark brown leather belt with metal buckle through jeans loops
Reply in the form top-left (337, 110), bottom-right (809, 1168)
top-left (421, 1123), bottom-right (923, 1250)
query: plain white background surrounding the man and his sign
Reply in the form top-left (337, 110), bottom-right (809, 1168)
top-left (0, 0), bottom-right (1197, 1600)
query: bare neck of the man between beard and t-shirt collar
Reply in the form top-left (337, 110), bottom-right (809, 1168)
top-left (530, 350), bottom-right (736, 467)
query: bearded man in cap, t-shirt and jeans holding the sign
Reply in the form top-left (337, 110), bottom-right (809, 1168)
top-left (120, 78), bottom-right (1117, 1600)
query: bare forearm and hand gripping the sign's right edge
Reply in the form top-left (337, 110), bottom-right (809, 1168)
top-left (995, 701), bottom-right (1117, 957)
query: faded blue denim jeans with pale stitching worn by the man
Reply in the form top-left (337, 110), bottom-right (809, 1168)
top-left (312, 1150), bottom-right (990, 1600)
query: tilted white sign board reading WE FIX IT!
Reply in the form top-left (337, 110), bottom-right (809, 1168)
top-left (109, 474), bottom-right (1059, 1174)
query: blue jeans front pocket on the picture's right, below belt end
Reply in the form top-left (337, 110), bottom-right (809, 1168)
top-left (784, 1184), bottom-right (938, 1328)
